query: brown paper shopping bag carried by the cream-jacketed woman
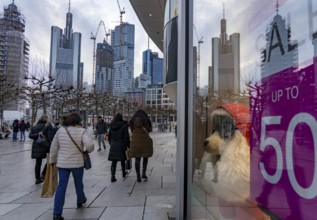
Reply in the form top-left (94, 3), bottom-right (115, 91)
top-left (41, 163), bottom-right (58, 198)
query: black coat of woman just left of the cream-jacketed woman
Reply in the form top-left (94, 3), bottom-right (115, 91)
top-left (29, 123), bottom-right (48, 159)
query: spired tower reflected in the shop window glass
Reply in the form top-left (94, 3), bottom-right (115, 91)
top-left (209, 10), bottom-right (240, 96)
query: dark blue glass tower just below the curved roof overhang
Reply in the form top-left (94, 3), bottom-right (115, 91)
top-left (142, 49), bottom-right (164, 85)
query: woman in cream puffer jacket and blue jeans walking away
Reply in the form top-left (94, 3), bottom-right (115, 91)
top-left (49, 112), bottom-right (94, 220)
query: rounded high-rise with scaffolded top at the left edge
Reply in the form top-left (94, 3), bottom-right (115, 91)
top-left (0, 1), bottom-right (30, 111)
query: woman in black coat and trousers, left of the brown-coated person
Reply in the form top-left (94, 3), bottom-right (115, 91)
top-left (108, 113), bottom-right (130, 182)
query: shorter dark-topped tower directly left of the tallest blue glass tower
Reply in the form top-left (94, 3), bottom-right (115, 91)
top-left (95, 40), bottom-right (114, 94)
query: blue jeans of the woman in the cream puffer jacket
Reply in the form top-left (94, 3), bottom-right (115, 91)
top-left (53, 167), bottom-right (86, 215)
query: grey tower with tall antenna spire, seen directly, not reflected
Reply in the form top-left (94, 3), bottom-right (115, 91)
top-left (50, 2), bottom-right (84, 89)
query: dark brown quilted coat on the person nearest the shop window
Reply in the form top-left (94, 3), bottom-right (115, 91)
top-left (129, 118), bottom-right (153, 158)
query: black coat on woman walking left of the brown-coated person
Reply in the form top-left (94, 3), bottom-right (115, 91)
top-left (108, 122), bottom-right (130, 161)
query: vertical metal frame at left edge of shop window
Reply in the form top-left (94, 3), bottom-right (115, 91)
top-left (176, 0), bottom-right (194, 220)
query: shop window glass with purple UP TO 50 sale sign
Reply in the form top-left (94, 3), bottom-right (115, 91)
top-left (188, 0), bottom-right (317, 219)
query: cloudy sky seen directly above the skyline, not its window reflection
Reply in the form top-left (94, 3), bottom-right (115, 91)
top-left (0, 0), bottom-right (162, 84)
